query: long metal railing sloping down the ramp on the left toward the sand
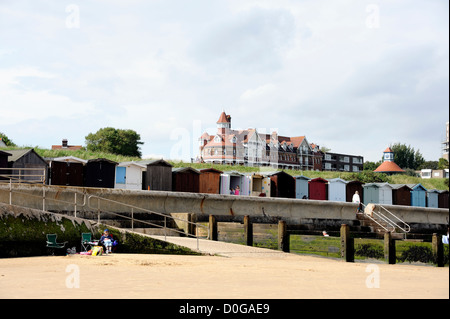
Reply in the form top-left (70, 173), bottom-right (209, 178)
top-left (0, 180), bottom-right (211, 250)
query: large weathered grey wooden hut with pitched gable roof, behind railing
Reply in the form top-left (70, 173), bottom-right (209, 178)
top-left (7, 149), bottom-right (48, 184)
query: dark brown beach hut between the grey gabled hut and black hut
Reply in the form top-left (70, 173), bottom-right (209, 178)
top-left (48, 156), bottom-right (87, 186)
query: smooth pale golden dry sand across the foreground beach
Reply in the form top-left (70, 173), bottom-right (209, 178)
top-left (0, 253), bottom-right (449, 299)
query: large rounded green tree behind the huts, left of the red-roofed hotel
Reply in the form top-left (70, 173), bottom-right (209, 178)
top-left (85, 127), bottom-right (144, 157)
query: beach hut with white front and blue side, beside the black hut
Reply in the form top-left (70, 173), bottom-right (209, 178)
top-left (114, 162), bottom-right (146, 190)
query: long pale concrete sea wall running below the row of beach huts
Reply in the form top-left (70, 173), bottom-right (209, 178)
top-left (0, 185), bottom-right (449, 233)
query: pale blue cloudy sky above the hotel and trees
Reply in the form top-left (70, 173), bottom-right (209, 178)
top-left (0, 0), bottom-right (449, 162)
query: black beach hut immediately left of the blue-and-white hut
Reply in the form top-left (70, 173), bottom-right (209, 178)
top-left (84, 158), bottom-right (118, 188)
